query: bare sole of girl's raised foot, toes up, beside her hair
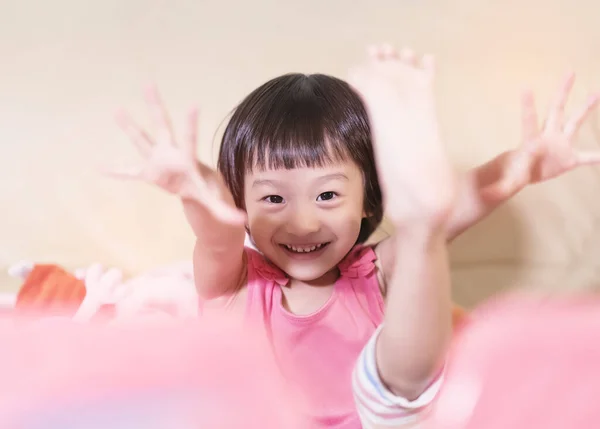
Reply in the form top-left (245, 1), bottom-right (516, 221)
top-left (349, 45), bottom-right (456, 224)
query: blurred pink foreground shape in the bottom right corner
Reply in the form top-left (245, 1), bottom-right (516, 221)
top-left (426, 297), bottom-right (600, 429)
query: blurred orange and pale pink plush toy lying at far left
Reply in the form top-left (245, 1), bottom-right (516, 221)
top-left (10, 262), bottom-right (198, 321)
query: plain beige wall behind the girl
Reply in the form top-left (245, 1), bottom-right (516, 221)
top-left (0, 0), bottom-right (600, 304)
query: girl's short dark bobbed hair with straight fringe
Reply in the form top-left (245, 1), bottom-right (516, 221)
top-left (217, 73), bottom-right (383, 243)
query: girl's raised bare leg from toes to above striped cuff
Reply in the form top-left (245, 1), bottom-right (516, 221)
top-left (351, 46), bottom-right (456, 412)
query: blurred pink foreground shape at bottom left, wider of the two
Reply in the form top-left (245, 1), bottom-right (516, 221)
top-left (0, 318), bottom-right (303, 429)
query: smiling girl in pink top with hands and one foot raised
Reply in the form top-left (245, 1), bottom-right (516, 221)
top-left (110, 46), bottom-right (600, 428)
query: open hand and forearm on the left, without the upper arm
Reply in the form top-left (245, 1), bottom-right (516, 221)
top-left (109, 83), bottom-right (245, 224)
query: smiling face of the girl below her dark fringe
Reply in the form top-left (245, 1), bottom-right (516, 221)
top-left (244, 162), bottom-right (365, 282)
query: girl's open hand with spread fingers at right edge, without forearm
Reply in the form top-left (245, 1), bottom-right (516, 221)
top-left (481, 73), bottom-right (600, 200)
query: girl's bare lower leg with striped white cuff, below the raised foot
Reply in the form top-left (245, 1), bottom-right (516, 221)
top-left (353, 228), bottom-right (451, 429)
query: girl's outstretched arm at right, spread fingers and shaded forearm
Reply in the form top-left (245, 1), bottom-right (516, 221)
top-left (447, 73), bottom-right (600, 240)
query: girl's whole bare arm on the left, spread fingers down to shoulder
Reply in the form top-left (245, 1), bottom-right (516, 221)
top-left (112, 88), bottom-right (245, 299)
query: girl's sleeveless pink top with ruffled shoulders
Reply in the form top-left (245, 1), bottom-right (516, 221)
top-left (246, 246), bottom-right (383, 429)
